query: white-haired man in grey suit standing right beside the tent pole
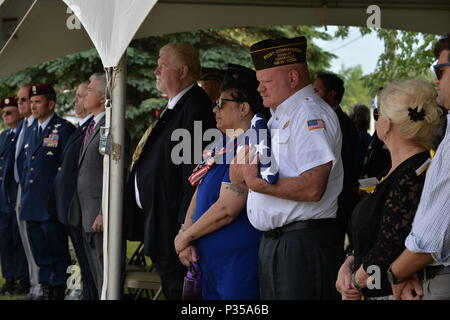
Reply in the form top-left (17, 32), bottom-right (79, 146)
top-left (69, 73), bottom-right (106, 299)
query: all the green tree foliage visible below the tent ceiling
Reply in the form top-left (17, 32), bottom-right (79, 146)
top-left (0, 26), bottom-right (438, 139)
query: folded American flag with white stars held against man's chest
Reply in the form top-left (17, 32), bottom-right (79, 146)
top-left (244, 113), bottom-right (278, 184)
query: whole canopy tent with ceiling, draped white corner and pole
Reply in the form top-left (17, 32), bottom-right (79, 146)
top-left (0, 0), bottom-right (450, 299)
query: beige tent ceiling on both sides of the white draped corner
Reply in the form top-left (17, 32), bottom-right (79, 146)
top-left (0, 0), bottom-right (450, 77)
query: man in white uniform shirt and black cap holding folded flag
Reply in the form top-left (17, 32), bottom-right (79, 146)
top-left (232, 37), bottom-right (343, 299)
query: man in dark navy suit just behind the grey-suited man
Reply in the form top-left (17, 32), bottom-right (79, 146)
top-left (49, 81), bottom-right (98, 300)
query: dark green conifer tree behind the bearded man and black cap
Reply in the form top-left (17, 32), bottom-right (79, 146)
top-left (0, 26), bottom-right (335, 144)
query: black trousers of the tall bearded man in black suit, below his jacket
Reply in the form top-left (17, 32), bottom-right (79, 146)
top-left (150, 255), bottom-right (187, 300)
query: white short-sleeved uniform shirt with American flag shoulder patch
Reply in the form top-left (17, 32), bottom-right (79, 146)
top-left (247, 85), bottom-right (343, 231)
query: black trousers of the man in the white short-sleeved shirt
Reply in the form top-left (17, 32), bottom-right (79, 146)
top-left (259, 222), bottom-right (344, 300)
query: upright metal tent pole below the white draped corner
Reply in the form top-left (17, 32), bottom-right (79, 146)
top-left (107, 51), bottom-right (127, 300)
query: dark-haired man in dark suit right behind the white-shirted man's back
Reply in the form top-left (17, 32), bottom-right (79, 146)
top-left (313, 73), bottom-right (358, 248)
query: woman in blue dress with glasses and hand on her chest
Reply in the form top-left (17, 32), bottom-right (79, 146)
top-left (175, 64), bottom-right (264, 300)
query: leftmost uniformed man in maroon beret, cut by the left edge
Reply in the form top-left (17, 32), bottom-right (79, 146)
top-left (0, 97), bottom-right (30, 294)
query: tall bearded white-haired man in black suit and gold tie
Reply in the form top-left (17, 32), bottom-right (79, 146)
top-left (126, 43), bottom-right (215, 299)
